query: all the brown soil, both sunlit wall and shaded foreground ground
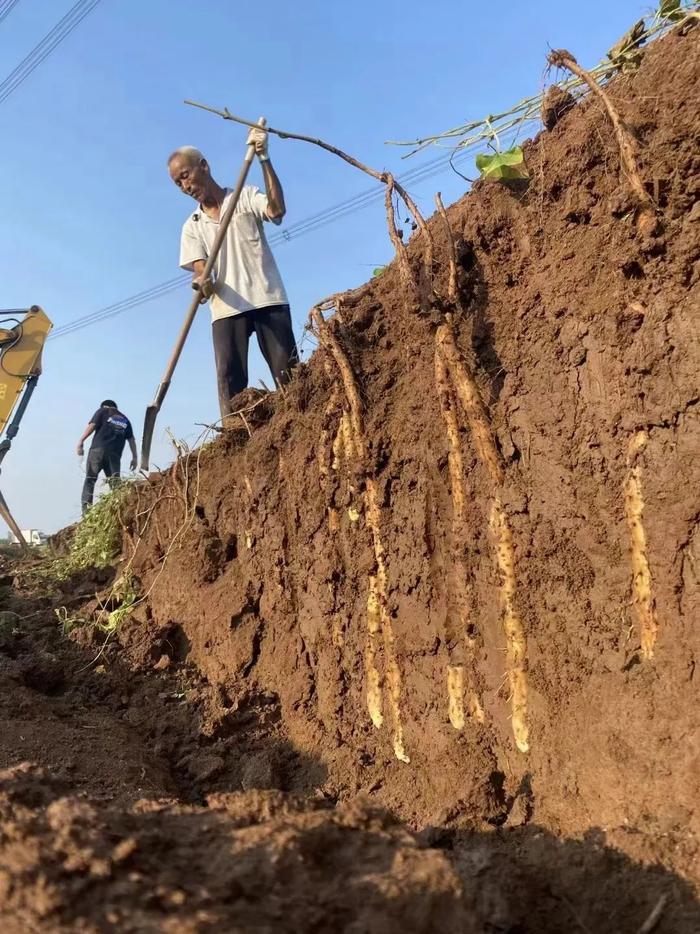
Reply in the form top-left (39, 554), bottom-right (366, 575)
top-left (0, 29), bottom-right (700, 934)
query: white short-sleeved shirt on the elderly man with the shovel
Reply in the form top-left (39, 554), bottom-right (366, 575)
top-left (180, 185), bottom-right (289, 321)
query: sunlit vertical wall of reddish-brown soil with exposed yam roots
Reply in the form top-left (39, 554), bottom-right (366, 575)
top-left (122, 30), bottom-right (700, 864)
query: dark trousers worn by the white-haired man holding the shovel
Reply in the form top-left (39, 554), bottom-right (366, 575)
top-left (213, 305), bottom-right (299, 418)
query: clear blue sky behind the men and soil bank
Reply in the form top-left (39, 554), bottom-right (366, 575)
top-left (0, 0), bottom-right (647, 534)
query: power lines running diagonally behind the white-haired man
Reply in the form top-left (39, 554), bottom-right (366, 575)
top-left (49, 150), bottom-right (476, 340)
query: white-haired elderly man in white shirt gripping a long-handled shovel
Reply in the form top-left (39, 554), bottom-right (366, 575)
top-left (168, 129), bottom-right (298, 418)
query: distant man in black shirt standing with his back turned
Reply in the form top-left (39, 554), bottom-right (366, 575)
top-left (78, 399), bottom-right (137, 513)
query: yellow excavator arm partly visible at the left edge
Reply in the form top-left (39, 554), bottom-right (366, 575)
top-left (0, 305), bottom-right (52, 548)
